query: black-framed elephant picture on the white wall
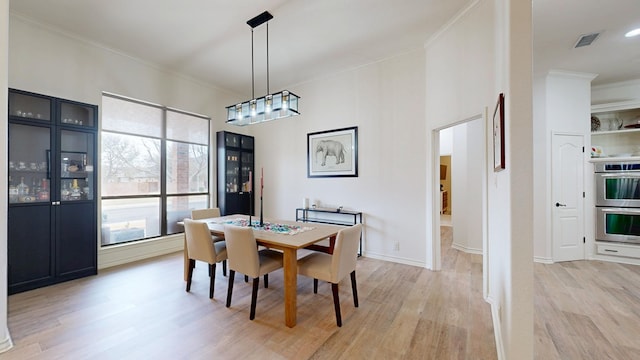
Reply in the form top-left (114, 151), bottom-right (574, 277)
top-left (307, 126), bottom-right (358, 178)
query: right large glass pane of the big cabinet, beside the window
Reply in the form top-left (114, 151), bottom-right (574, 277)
top-left (59, 130), bottom-right (95, 201)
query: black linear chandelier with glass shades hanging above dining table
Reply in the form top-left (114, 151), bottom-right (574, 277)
top-left (227, 11), bottom-right (300, 126)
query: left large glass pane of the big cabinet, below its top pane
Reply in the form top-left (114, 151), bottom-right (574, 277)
top-left (8, 124), bottom-right (51, 204)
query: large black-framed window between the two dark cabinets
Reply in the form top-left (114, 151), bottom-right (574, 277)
top-left (100, 94), bottom-right (210, 246)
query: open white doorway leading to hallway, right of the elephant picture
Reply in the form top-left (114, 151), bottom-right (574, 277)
top-left (432, 115), bottom-right (488, 297)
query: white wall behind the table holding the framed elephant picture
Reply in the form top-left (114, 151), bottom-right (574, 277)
top-left (253, 50), bottom-right (427, 266)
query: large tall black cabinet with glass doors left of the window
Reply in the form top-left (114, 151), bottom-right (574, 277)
top-left (8, 89), bottom-right (98, 294)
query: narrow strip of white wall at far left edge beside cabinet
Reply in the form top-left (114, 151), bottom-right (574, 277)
top-left (0, 0), bottom-right (12, 353)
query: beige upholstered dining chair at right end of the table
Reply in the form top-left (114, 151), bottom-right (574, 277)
top-left (298, 224), bottom-right (362, 326)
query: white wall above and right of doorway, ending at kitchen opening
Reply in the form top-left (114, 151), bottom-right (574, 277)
top-left (426, 0), bottom-right (533, 359)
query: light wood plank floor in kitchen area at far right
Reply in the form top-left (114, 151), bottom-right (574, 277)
top-left (534, 261), bottom-right (640, 360)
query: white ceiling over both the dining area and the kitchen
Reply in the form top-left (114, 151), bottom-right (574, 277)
top-left (10, 0), bottom-right (640, 97)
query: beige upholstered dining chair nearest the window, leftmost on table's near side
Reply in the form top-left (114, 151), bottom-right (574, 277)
top-left (184, 219), bottom-right (227, 299)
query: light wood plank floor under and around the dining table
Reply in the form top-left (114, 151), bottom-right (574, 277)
top-left (0, 227), bottom-right (496, 360)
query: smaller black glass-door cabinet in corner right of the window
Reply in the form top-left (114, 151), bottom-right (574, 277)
top-left (216, 131), bottom-right (255, 215)
